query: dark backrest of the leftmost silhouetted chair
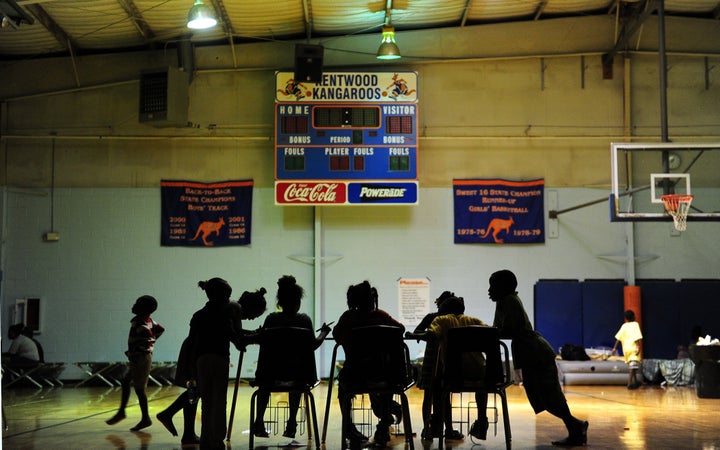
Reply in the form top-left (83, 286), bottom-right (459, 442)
top-left (254, 327), bottom-right (318, 386)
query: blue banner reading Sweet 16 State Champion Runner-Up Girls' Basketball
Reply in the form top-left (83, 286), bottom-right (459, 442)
top-left (453, 179), bottom-right (545, 244)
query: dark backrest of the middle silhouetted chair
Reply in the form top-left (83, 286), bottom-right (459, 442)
top-left (339, 325), bottom-right (414, 389)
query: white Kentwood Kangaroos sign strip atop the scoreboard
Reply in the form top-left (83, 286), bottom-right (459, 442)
top-left (275, 72), bottom-right (417, 103)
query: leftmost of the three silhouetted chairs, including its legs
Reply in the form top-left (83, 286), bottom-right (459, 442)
top-left (250, 327), bottom-right (320, 450)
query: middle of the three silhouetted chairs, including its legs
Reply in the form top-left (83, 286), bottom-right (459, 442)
top-left (338, 325), bottom-right (415, 450)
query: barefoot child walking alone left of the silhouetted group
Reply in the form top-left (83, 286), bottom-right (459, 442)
top-left (105, 295), bottom-right (165, 431)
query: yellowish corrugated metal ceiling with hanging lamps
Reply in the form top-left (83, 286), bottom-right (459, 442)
top-left (0, 0), bottom-right (720, 59)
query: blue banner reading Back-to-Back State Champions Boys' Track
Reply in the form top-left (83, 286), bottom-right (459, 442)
top-left (160, 180), bottom-right (253, 247)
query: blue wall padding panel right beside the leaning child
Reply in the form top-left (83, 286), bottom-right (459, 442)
top-left (534, 280), bottom-right (583, 353)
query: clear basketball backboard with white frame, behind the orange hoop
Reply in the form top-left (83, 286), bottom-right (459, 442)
top-left (610, 143), bottom-right (720, 222)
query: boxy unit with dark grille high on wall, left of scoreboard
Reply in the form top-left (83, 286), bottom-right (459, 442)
top-left (138, 67), bottom-right (190, 127)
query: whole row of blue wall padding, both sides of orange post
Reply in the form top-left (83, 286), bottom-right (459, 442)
top-left (534, 279), bottom-right (720, 359)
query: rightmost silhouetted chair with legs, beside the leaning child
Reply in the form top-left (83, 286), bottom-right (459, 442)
top-left (440, 325), bottom-right (512, 449)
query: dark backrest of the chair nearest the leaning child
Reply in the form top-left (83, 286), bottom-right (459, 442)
top-left (443, 325), bottom-right (511, 390)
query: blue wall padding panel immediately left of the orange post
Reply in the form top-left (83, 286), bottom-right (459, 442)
top-left (580, 280), bottom-right (625, 348)
